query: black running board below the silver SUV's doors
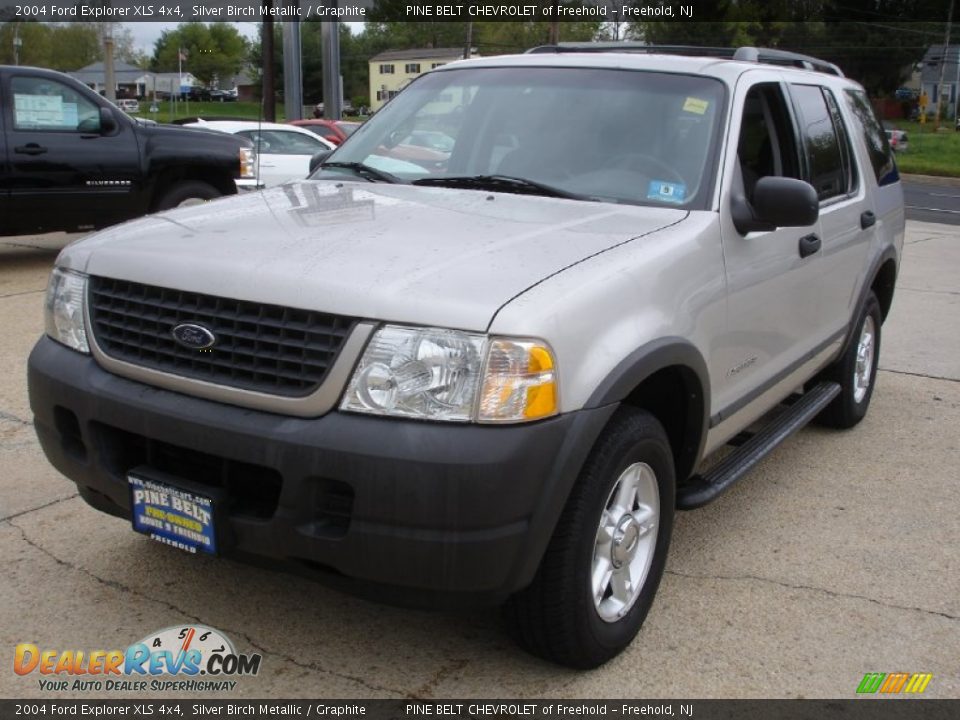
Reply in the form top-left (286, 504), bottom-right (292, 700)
top-left (677, 382), bottom-right (840, 510)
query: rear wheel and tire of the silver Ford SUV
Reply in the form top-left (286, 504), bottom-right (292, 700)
top-left (817, 291), bottom-right (883, 428)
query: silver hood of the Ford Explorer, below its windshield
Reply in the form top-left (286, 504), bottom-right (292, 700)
top-left (59, 181), bottom-right (687, 331)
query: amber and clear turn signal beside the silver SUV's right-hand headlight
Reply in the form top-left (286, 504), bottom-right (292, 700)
top-left (477, 339), bottom-right (558, 423)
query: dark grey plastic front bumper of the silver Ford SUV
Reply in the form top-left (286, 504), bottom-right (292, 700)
top-left (29, 337), bottom-right (613, 605)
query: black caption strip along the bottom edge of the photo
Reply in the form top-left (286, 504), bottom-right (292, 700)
top-left (0, 698), bottom-right (960, 720)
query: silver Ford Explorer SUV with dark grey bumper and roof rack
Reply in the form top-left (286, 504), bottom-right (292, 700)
top-left (29, 47), bottom-right (904, 667)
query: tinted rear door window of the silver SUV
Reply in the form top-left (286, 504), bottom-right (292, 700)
top-left (791, 85), bottom-right (850, 200)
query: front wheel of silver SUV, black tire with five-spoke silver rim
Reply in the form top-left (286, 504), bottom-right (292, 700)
top-left (504, 406), bottom-right (675, 669)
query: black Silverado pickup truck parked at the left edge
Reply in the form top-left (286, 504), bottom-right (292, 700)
top-left (0, 65), bottom-right (256, 235)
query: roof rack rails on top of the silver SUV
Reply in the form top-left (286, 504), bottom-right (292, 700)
top-left (527, 42), bottom-right (843, 77)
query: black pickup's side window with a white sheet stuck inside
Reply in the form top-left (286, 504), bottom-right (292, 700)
top-left (11, 77), bottom-right (100, 133)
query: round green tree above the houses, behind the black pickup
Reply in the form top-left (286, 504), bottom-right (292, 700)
top-left (151, 22), bottom-right (250, 85)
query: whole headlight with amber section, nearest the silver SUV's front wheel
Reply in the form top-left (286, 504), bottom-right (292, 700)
top-left (340, 325), bottom-right (557, 423)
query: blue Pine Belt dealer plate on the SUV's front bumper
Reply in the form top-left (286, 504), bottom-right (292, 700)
top-left (127, 475), bottom-right (217, 554)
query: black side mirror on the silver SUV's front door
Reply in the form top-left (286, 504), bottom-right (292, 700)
top-left (732, 176), bottom-right (820, 235)
